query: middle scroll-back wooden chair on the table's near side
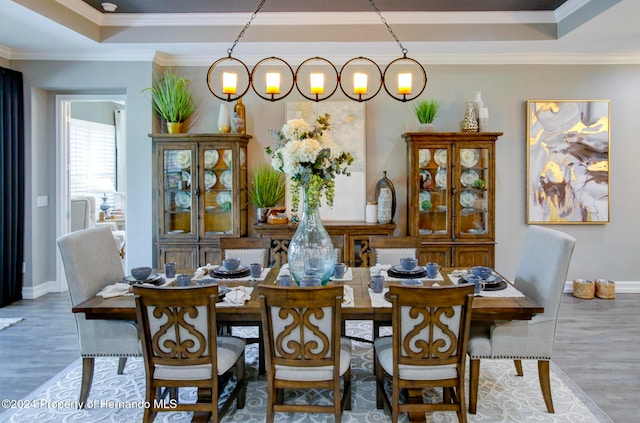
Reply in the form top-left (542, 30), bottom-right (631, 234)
top-left (259, 286), bottom-right (351, 422)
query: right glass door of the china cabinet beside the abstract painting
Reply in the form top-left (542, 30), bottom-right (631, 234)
top-left (455, 148), bottom-right (491, 237)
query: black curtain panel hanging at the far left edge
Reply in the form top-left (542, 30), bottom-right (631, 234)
top-left (0, 67), bottom-right (25, 307)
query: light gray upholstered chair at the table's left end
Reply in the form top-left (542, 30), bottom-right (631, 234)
top-left (58, 227), bottom-right (142, 404)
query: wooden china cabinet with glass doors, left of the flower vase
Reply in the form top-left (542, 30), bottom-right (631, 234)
top-left (150, 134), bottom-right (251, 269)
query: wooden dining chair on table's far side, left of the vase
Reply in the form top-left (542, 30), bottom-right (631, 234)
top-left (220, 237), bottom-right (271, 375)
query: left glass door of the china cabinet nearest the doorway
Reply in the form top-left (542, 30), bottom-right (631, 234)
top-left (160, 144), bottom-right (196, 237)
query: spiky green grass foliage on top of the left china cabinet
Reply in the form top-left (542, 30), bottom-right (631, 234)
top-left (145, 70), bottom-right (196, 123)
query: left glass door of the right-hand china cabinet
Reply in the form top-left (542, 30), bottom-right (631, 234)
top-left (418, 147), bottom-right (451, 235)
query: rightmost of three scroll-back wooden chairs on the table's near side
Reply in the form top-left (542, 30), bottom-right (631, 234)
top-left (374, 284), bottom-right (473, 423)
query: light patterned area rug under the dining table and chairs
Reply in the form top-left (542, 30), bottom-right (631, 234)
top-left (0, 322), bottom-right (611, 423)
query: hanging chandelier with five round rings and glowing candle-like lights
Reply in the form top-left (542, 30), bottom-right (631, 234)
top-left (207, 0), bottom-right (427, 102)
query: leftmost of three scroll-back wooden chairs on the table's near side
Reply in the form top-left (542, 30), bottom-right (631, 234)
top-left (133, 285), bottom-right (246, 423)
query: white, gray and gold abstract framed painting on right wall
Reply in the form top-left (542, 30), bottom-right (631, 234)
top-left (526, 100), bottom-right (610, 224)
